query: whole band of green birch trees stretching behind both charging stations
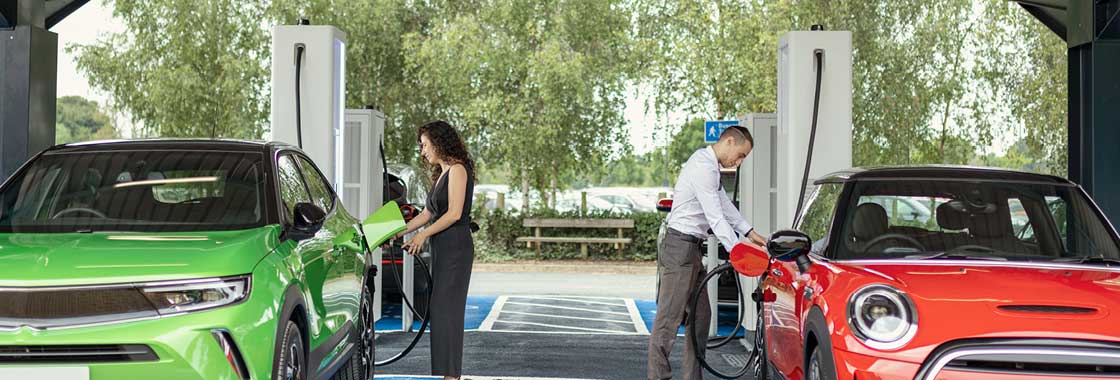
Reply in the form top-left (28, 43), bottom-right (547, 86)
top-left (74, 0), bottom-right (1066, 191)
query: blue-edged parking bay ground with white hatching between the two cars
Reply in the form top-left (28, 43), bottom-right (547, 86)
top-left (375, 295), bottom-right (748, 380)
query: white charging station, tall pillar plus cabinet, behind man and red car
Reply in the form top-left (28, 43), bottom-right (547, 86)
top-left (734, 30), bottom-right (852, 346)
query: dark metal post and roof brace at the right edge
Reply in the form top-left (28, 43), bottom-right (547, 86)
top-left (1016, 0), bottom-right (1120, 223)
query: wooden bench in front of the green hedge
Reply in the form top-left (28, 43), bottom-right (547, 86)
top-left (516, 219), bottom-right (634, 259)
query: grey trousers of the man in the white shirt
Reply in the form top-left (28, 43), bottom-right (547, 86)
top-left (646, 229), bottom-right (711, 380)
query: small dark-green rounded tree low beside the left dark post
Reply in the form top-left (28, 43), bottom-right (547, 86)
top-left (55, 96), bottom-right (119, 143)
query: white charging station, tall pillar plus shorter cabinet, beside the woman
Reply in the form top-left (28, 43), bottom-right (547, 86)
top-left (270, 25), bottom-right (392, 325)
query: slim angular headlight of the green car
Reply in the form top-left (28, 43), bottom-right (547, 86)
top-left (142, 276), bottom-right (250, 315)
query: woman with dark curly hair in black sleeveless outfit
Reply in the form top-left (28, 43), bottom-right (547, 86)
top-left (401, 121), bottom-right (475, 379)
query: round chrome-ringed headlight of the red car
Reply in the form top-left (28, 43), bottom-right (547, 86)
top-left (848, 284), bottom-right (917, 350)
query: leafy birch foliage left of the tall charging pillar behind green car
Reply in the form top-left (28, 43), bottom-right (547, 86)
top-left (66, 0), bottom-right (269, 139)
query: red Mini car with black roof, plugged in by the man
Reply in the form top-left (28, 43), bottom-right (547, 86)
top-left (732, 167), bottom-right (1120, 380)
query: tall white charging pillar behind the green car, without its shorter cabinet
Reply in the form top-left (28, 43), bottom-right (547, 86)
top-left (270, 25), bottom-right (346, 198)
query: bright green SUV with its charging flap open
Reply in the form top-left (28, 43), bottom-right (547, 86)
top-left (0, 140), bottom-right (404, 380)
